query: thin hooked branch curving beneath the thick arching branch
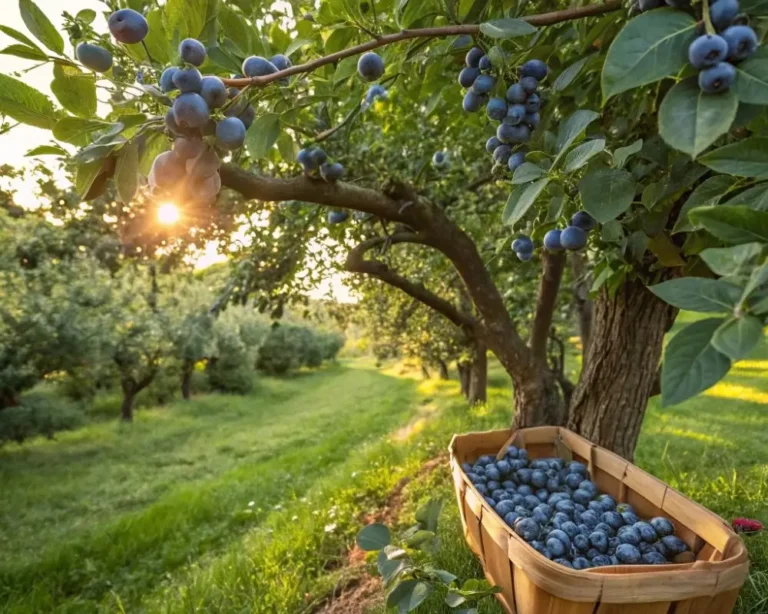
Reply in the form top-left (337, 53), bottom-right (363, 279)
top-left (344, 233), bottom-right (476, 330)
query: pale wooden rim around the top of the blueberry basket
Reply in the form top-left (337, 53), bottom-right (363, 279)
top-left (448, 427), bottom-right (749, 594)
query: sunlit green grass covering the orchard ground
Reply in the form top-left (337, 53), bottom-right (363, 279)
top-left (0, 314), bottom-right (768, 614)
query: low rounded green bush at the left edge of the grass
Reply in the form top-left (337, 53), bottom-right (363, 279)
top-left (0, 393), bottom-right (85, 446)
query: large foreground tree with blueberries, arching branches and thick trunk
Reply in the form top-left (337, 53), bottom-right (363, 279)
top-left (0, 0), bottom-right (768, 458)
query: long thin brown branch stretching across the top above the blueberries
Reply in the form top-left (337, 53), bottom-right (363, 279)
top-left (223, 0), bottom-right (621, 87)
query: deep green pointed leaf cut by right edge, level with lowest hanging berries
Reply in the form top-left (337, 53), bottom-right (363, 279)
top-left (688, 205), bottom-right (768, 245)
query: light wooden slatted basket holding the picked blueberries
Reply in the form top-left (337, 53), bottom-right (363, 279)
top-left (449, 426), bottom-right (749, 614)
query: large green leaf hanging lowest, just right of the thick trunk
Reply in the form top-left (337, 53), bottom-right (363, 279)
top-left (661, 318), bottom-right (731, 407)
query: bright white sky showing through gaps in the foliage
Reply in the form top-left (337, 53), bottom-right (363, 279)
top-left (0, 0), bottom-right (354, 302)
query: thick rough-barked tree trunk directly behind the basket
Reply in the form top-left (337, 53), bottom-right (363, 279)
top-left (568, 280), bottom-right (677, 461)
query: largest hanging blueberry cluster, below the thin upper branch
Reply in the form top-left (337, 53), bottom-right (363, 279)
top-left (459, 47), bottom-right (549, 176)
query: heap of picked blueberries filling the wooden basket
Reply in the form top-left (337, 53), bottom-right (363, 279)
top-left (462, 446), bottom-right (691, 569)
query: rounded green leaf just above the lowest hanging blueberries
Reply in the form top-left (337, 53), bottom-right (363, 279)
top-left (579, 168), bottom-right (635, 224)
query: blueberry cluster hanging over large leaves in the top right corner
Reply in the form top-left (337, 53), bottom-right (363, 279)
top-left (688, 0), bottom-right (759, 94)
